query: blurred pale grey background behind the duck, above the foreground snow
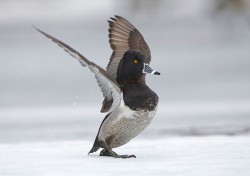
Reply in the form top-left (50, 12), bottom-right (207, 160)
top-left (0, 0), bottom-right (250, 142)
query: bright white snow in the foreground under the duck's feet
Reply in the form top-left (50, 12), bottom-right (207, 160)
top-left (0, 136), bottom-right (250, 176)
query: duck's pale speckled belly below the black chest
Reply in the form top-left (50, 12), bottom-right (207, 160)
top-left (98, 104), bottom-right (157, 148)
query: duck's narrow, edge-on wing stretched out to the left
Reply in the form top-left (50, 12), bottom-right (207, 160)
top-left (34, 27), bottom-right (122, 113)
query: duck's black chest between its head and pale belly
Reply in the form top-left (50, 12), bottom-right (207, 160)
top-left (123, 82), bottom-right (158, 111)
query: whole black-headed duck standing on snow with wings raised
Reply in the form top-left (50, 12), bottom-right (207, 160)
top-left (34, 15), bottom-right (160, 158)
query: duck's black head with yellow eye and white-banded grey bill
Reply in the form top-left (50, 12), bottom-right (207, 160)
top-left (118, 50), bottom-right (160, 82)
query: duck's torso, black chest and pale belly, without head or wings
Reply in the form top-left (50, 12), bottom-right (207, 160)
top-left (94, 82), bottom-right (158, 148)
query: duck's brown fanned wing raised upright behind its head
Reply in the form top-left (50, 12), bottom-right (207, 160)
top-left (107, 15), bottom-right (151, 80)
